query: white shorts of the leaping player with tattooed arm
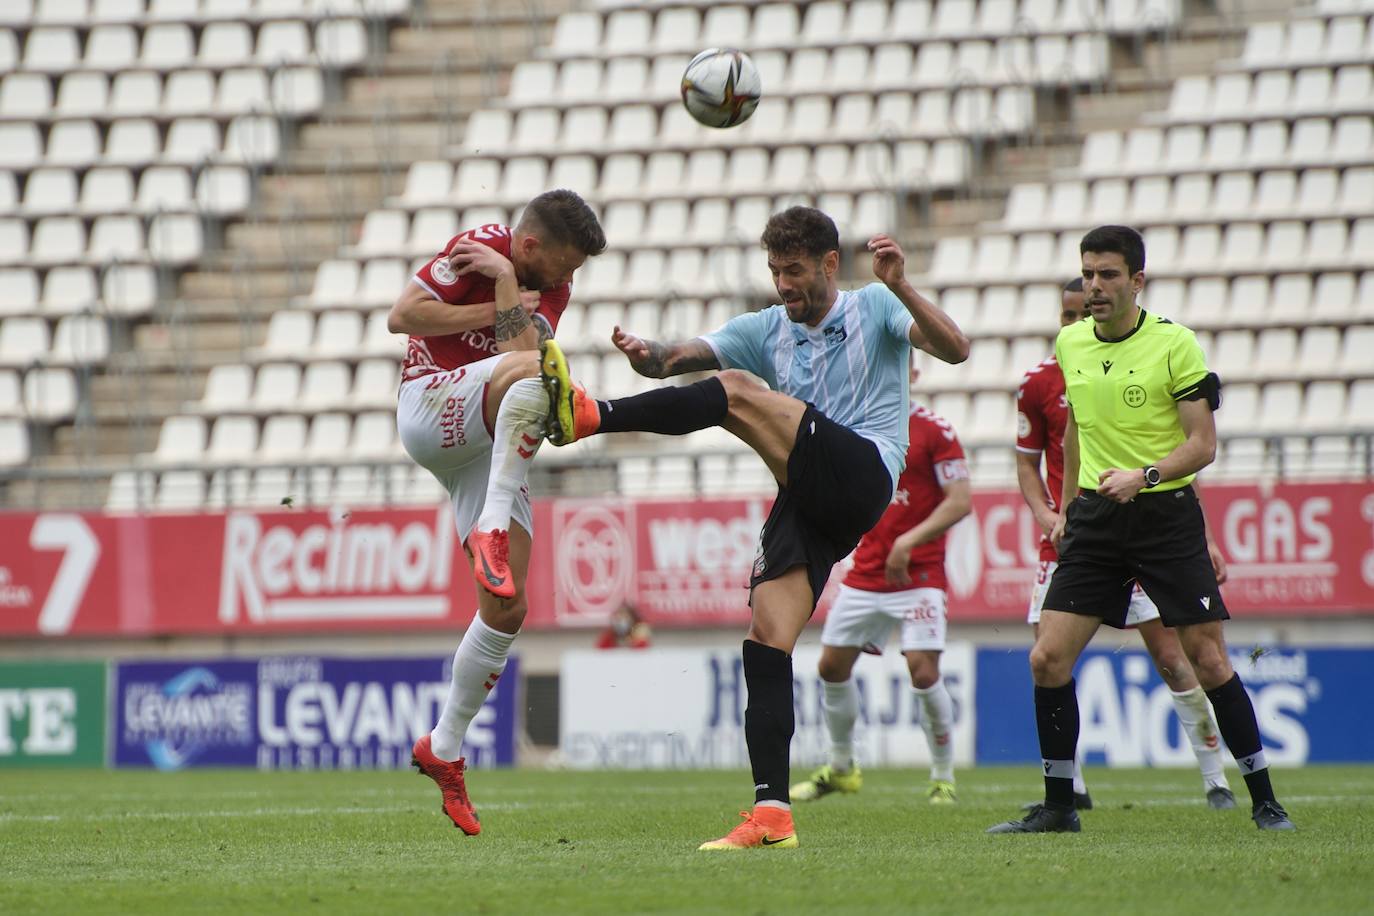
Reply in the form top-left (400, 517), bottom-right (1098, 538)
top-left (396, 353), bottom-right (534, 542)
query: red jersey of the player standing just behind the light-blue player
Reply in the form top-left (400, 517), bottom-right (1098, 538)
top-left (845, 407), bottom-right (969, 592)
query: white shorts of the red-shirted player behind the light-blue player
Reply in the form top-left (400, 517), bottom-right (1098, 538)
top-left (820, 585), bottom-right (947, 652)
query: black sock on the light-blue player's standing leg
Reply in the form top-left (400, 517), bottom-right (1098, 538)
top-left (745, 640), bottom-right (797, 803)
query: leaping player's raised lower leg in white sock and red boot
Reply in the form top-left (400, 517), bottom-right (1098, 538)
top-left (467, 378), bottom-right (548, 599)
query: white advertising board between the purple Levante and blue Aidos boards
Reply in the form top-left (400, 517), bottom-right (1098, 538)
top-left (559, 643), bottom-right (974, 769)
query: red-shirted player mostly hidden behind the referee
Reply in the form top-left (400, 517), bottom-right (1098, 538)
top-left (1017, 277), bottom-right (1235, 809)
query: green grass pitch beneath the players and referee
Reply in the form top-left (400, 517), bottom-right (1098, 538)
top-left (0, 766), bottom-right (1374, 916)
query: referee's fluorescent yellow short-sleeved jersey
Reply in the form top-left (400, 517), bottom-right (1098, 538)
top-left (1054, 309), bottom-right (1208, 493)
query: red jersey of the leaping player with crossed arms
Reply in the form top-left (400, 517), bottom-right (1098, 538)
top-left (401, 222), bottom-right (572, 379)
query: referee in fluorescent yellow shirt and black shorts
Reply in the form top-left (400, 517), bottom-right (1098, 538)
top-left (988, 225), bottom-right (1293, 834)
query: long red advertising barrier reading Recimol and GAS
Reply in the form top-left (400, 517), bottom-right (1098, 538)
top-left (0, 483), bottom-right (1374, 637)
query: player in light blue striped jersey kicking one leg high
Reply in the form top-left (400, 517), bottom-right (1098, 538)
top-left (541, 207), bottom-right (969, 849)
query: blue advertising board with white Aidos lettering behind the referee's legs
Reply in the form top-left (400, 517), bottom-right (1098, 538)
top-left (977, 648), bottom-right (1374, 766)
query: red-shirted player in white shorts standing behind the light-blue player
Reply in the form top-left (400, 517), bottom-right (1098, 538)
top-left (791, 371), bottom-right (971, 803)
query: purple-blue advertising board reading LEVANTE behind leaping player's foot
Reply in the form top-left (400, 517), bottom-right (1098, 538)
top-left (110, 656), bottom-right (518, 770)
